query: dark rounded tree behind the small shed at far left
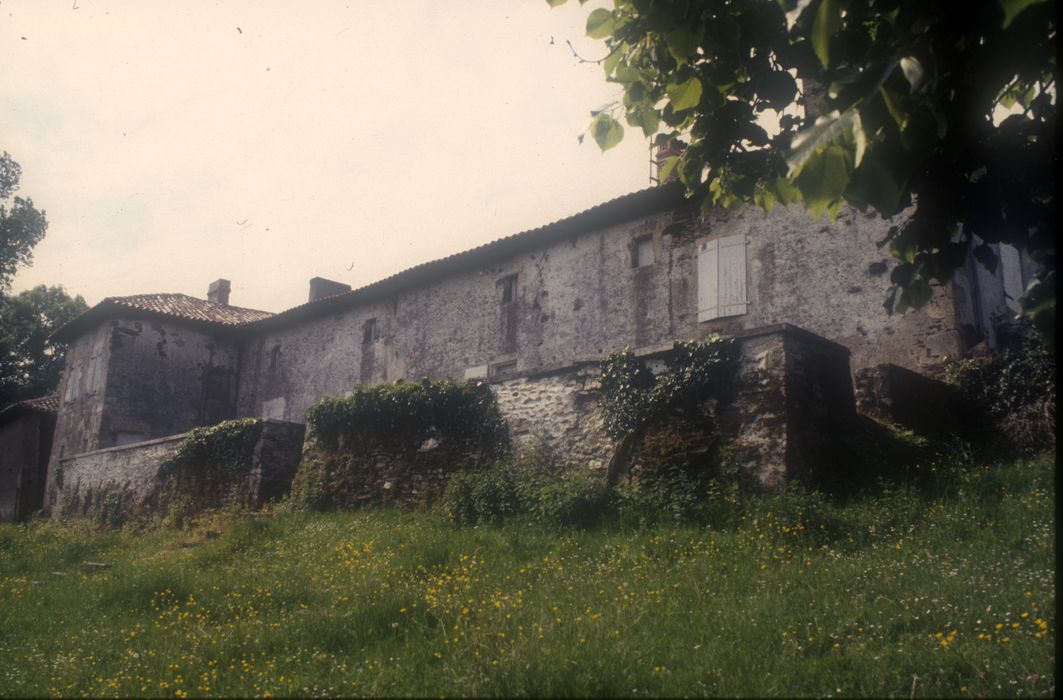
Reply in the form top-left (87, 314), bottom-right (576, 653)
top-left (0, 285), bottom-right (88, 408)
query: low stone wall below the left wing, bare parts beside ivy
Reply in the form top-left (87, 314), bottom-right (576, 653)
top-left (54, 420), bottom-right (305, 520)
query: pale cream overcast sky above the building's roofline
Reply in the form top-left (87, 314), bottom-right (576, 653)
top-left (0, 0), bottom-right (649, 311)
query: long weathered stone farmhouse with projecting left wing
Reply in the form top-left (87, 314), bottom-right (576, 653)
top-left (31, 178), bottom-right (1030, 511)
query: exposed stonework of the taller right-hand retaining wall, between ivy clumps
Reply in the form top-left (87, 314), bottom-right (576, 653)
top-left (493, 324), bottom-right (856, 486)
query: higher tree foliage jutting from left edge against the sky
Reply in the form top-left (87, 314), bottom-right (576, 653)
top-left (0, 151), bottom-right (48, 292)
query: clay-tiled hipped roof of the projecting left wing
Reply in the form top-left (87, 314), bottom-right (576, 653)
top-left (52, 294), bottom-right (273, 342)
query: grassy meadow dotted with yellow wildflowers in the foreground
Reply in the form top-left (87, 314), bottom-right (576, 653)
top-left (0, 455), bottom-right (1056, 698)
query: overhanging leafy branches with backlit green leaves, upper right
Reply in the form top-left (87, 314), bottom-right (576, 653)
top-left (547, 0), bottom-right (1058, 344)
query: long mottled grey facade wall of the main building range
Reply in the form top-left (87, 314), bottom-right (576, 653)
top-left (232, 199), bottom-right (960, 422)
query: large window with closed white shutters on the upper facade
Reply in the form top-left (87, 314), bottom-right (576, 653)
top-left (697, 235), bottom-right (748, 321)
